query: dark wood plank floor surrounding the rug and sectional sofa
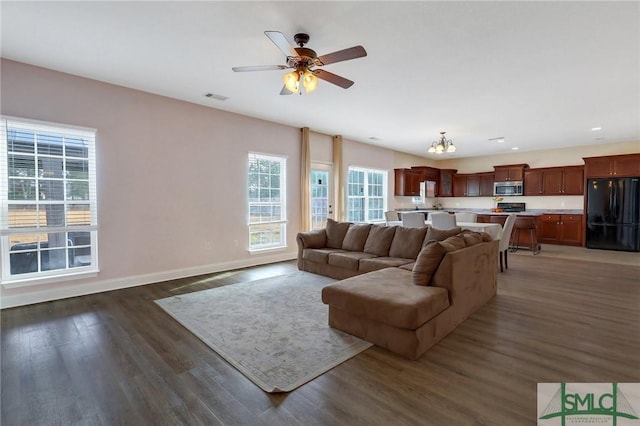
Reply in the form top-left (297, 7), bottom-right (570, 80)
top-left (1, 256), bottom-right (640, 426)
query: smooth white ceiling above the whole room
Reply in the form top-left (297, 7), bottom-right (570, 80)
top-left (1, 1), bottom-right (640, 158)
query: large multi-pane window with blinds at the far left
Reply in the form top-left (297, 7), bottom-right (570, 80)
top-left (0, 117), bottom-right (98, 283)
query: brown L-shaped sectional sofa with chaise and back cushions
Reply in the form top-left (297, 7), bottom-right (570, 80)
top-left (297, 220), bottom-right (498, 359)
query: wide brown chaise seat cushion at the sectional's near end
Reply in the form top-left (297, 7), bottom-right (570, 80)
top-left (322, 268), bottom-right (449, 330)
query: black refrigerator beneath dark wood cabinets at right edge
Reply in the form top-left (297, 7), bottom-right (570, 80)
top-left (586, 177), bottom-right (640, 251)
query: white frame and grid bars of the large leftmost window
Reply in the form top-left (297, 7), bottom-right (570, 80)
top-left (0, 115), bottom-right (99, 287)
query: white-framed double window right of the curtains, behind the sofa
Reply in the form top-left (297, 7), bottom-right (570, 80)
top-left (347, 167), bottom-right (387, 222)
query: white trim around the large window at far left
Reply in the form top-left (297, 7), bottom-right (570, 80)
top-left (0, 115), bottom-right (99, 288)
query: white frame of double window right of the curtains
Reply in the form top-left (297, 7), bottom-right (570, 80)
top-left (345, 166), bottom-right (389, 223)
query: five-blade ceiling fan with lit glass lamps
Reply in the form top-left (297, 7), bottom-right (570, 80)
top-left (232, 31), bottom-right (367, 95)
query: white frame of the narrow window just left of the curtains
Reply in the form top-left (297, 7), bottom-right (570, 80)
top-left (247, 152), bottom-right (288, 253)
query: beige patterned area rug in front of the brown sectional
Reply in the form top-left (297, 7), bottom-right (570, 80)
top-left (156, 271), bottom-right (372, 392)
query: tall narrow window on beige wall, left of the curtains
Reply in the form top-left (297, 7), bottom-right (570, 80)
top-left (248, 153), bottom-right (287, 250)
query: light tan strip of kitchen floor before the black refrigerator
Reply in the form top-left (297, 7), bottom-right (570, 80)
top-left (509, 244), bottom-right (640, 266)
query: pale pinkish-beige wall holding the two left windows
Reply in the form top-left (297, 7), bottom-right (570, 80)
top-left (1, 60), bottom-right (300, 306)
